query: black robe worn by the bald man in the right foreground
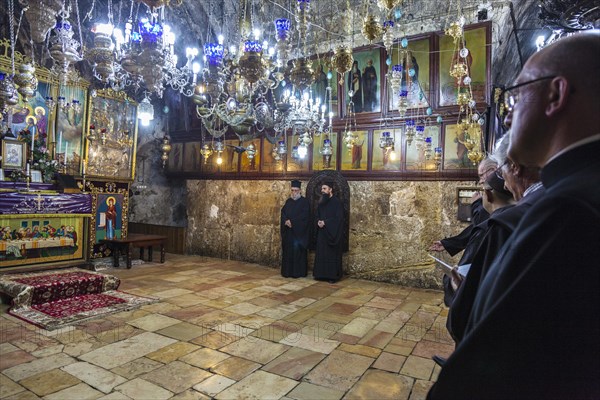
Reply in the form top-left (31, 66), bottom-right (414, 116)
top-left (428, 140), bottom-right (600, 399)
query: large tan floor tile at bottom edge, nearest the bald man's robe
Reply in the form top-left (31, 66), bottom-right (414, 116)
top-left (344, 369), bottom-right (413, 400)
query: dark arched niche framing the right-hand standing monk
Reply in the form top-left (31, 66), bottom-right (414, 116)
top-left (306, 170), bottom-right (350, 252)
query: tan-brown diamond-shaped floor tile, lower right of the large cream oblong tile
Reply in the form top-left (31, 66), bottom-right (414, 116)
top-left (141, 361), bottom-right (212, 393)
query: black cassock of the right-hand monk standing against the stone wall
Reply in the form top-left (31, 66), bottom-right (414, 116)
top-left (313, 196), bottom-right (344, 281)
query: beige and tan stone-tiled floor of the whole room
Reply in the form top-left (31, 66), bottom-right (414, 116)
top-left (0, 255), bottom-right (453, 400)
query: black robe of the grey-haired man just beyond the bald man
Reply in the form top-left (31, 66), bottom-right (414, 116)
top-left (446, 187), bottom-right (544, 343)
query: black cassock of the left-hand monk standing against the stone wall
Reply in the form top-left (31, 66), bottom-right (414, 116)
top-left (280, 197), bottom-right (310, 278)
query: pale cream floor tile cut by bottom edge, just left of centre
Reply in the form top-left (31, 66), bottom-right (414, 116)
top-left (215, 371), bottom-right (298, 400)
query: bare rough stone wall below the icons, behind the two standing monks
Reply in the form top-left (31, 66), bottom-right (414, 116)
top-left (186, 180), bottom-right (472, 288)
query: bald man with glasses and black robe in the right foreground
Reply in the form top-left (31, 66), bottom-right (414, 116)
top-left (428, 31), bottom-right (600, 400)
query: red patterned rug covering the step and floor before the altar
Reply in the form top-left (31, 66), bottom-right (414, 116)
top-left (0, 268), bottom-right (157, 330)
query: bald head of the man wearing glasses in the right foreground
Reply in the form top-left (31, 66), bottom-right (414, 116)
top-left (506, 31), bottom-right (600, 167)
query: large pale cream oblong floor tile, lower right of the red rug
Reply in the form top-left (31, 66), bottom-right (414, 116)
top-left (79, 328), bottom-right (175, 369)
